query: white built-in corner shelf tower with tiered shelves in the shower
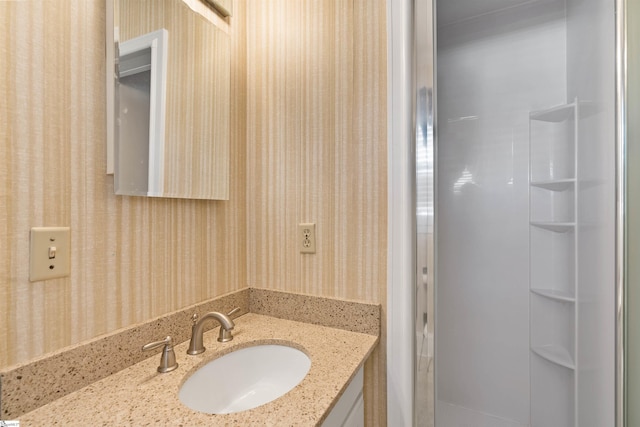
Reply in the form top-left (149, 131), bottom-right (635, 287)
top-left (529, 99), bottom-right (580, 427)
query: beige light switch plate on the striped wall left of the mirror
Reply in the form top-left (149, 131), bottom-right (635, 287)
top-left (29, 227), bottom-right (71, 282)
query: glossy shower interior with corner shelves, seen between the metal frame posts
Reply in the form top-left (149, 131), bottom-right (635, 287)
top-left (428, 0), bottom-right (615, 427)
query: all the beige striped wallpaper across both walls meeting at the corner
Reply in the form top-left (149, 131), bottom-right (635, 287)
top-left (0, 0), bottom-right (387, 425)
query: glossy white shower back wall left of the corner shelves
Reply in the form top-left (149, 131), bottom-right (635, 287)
top-left (436, 2), bottom-right (567, 427)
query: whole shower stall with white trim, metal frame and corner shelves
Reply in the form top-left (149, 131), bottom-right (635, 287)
top-left (388, 0), bottom-right (622, 427)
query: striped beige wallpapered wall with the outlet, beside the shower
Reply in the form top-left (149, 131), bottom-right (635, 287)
top-left (247, 0), bottom-right (387, 425)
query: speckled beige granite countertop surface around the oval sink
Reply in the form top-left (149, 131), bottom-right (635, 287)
top-left (19, 313), bottom-right (378, 427)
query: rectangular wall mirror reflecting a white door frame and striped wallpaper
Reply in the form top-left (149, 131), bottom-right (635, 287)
top-left (107, 0), bottom-right (231, 200)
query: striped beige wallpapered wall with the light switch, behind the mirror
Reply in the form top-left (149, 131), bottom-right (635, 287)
top-left (0, 0), bottom-right (246, 367)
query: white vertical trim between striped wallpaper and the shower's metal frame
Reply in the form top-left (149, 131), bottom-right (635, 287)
top-left (387, 0), bottom-right (416, 426)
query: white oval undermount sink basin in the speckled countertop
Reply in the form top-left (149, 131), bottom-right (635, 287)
top-left (178, 345), bottom-right (311, 414)
